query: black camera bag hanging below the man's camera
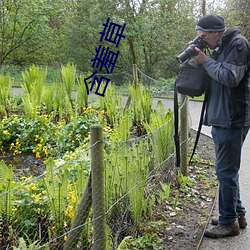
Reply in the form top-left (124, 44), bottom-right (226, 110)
top-left (175, 58), bottom-right (209, 97)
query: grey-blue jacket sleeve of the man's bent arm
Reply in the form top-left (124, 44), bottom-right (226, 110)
top-left (203, 37), bottom-right (250, 88)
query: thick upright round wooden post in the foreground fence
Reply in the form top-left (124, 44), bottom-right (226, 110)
top-left (90, 124), bottom-right (106, 250)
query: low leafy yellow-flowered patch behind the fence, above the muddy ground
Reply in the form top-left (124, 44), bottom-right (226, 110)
top-left (0, 106), bottom-right (104, 158)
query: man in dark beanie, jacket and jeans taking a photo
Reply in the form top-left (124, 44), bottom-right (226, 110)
top-left (193, 15), bottom-right (250, 238)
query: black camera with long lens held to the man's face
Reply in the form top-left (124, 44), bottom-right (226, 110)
top-left (176, 36), bottom-right (208, 63)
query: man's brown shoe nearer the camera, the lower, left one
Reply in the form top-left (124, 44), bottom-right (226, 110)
top-left (204, 222), bottom-right (240, 238)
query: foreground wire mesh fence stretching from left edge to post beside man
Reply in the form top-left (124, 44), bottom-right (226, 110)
top-left (0, 64), bottom-right (189, 250)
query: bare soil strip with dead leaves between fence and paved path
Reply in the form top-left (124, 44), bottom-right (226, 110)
top-left (158, 131), bottom-right (218, 250)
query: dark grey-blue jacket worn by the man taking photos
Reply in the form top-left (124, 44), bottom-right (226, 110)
top-left (203, 27), bottom-right (250, 128)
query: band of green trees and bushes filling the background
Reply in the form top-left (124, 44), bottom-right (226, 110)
top-left (0, 0), bottom-right (250, 83)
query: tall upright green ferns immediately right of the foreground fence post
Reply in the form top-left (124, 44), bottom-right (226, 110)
top-left (105, 135), bottom-right (152, 233)
